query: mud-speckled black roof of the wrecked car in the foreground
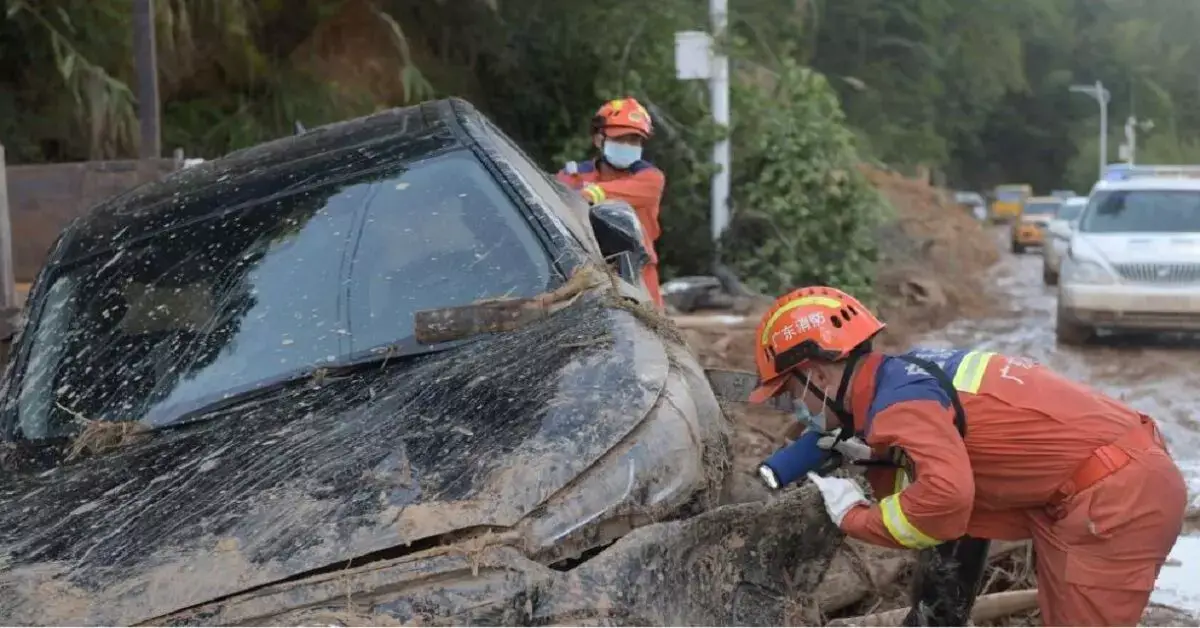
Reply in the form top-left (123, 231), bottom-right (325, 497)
top-left (50, 98), bottom-right (594, 263)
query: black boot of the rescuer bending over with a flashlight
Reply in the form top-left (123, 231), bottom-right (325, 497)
top-left (904, 537), bottom-right (991, 626)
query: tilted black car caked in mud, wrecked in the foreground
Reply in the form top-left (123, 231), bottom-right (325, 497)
top-left (0, 100), bottom-right (840, 626)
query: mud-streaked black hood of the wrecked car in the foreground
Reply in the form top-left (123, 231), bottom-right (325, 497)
top-left (0, 301), bottom-right (668, 626)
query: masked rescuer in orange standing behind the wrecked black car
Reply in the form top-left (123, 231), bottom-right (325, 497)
top-left (558, 98), bottom-right (666, 309)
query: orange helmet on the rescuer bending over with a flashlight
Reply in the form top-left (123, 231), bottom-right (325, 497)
top-left (750, 286), bottom-right (884, 403)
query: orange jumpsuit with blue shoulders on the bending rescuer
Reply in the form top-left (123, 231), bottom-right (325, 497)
top-left (842, 349), bottom-right (1187, 626)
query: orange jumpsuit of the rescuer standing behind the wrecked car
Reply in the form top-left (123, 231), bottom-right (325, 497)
top-left (557, 160), bottom-right (666, 310)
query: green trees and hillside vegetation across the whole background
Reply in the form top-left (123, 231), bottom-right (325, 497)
top-left (0, 0), bottom-right (1200, 291)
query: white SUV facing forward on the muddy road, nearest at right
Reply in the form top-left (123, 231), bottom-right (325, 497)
top-left (1055, 175), bottom-right (1200, 345)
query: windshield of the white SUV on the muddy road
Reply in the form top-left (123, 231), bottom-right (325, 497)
top-left (1079, 190), bottom-right (1200, 233)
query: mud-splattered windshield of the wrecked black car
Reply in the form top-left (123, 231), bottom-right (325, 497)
top-left (10, 151), bottom-right (551, 439)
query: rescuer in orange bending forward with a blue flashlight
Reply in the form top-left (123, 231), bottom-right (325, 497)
top-left (751, 287), bottom-right (1187, 626)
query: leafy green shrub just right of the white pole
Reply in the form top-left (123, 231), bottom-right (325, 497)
top-left (721, 58), bottom-right (886, 294)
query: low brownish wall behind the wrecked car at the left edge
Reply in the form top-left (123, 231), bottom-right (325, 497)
top-left (6, 159), bottom-right (181, 282)
